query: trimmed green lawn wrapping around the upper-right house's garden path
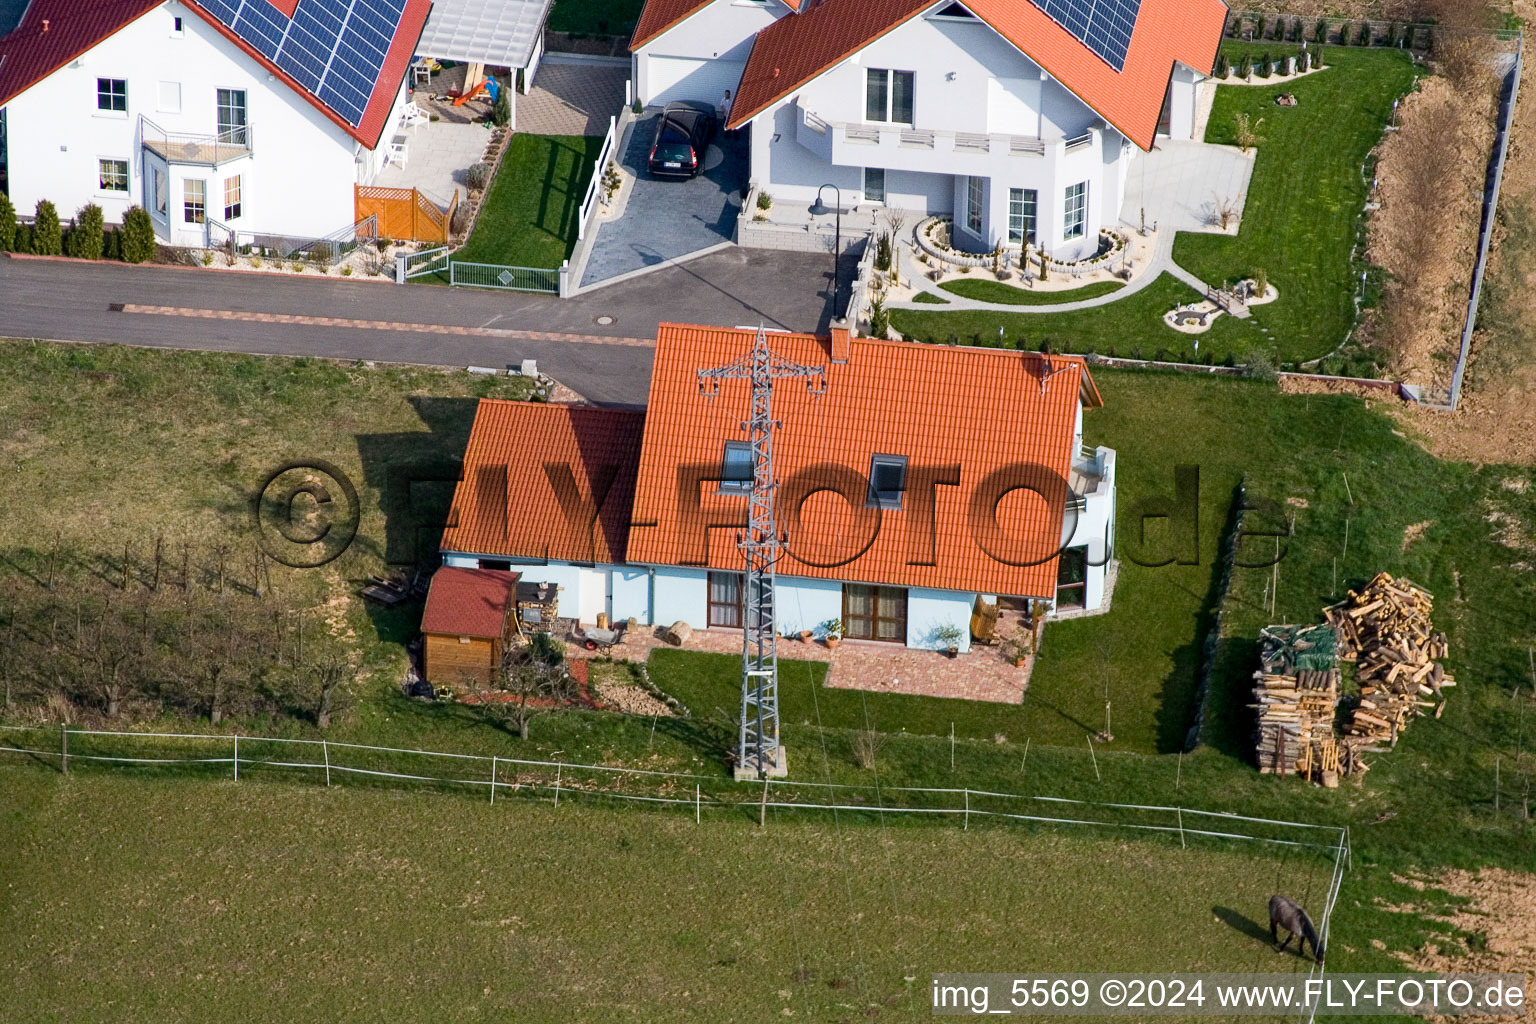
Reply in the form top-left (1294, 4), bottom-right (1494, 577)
top-left (891, 43), bottom-right (1418, 376)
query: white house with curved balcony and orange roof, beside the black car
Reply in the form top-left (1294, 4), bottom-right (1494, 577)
top-left (631, 0), bottom-right (1227, 261)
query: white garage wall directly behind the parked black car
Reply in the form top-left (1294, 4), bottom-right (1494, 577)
top-left (633, 0), bottom-right (788, 106)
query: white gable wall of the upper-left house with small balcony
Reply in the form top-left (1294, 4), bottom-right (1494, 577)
top-left (6, 0), bottom-right (371, 244)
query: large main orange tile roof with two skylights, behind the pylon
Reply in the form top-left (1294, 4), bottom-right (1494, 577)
top-left (628, 327), bottom-right (1100, 596)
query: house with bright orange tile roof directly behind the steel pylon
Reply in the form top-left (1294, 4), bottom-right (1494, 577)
top-left (442, 324), bottom-right (1115, 648)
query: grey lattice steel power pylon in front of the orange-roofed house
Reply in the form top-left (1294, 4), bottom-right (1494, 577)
top-left (699, 327), bottom-right (826, 778)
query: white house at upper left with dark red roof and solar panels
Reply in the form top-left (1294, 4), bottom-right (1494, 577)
top-left (0, 0), bottom-right (432, 246)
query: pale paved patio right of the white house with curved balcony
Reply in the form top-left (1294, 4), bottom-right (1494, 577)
top-left (1120, 138), bottom-right (1253, 235)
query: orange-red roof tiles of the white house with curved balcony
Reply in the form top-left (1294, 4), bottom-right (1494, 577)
top-left (728, 0), bottom-right (1227, 149)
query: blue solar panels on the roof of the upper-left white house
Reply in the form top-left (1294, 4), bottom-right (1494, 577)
top-left (200, 0), bottom-right (406, 127)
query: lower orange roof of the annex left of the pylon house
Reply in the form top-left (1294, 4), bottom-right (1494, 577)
top-left (442, 399), bottom-right (645, 562)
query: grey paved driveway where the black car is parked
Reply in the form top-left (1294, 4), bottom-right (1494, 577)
top-left (581, 112), bottom-right (748, 287)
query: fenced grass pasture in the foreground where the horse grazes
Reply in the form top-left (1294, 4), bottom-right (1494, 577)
top-left (0, 766), bottom-right (1330, 1024)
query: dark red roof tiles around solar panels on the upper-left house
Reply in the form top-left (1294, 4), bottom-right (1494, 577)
top-left (0, 0), bottom-right (432, 149)
